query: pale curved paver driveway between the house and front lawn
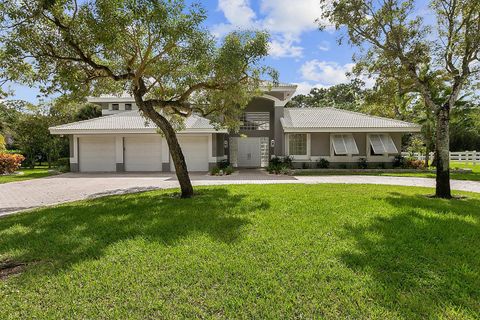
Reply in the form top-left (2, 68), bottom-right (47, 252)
top-left (0, 170), bottom-right (480, 216)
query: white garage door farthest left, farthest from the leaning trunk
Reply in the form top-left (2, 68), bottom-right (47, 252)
top-left (79, 137), bottom-right (116, 172)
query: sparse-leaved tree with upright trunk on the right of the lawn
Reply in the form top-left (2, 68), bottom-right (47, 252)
top-left (320, 0), bottom-right (480, 198)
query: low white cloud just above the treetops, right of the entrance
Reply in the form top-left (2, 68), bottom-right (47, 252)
top-left (300, 59), bottom-right (354, 86)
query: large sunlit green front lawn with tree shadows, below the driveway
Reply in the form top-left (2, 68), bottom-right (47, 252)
top-left (0, 185), bottom-right (480, 319)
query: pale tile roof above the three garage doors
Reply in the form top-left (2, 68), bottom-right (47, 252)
top-left (50, 110), bottom-right (223, 133)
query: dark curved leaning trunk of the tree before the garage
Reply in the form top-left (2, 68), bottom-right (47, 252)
top-left (137, 102), bottom-right (193, 198)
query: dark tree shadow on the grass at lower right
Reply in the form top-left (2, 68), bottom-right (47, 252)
top-left (342, 193), bottom-right (480, 319)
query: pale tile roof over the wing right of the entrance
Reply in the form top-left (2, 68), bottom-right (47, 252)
top-left (281, 108), bottom-right (420, 131)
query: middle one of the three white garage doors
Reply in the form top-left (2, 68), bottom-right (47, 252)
top-left (124, 135), bottom-right (162, 171)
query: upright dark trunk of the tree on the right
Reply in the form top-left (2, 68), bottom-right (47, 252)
top-left (435, 105), bottom-right (452, 199)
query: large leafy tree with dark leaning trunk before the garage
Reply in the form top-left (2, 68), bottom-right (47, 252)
top-left (0, 0), bottom-right (276, 197)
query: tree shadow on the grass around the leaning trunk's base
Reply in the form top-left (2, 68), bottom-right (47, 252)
top-left (0, 188), bottom-right (269, 274)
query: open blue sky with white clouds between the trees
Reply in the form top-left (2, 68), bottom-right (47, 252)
top-left (2, 0), bottom-right (432, 103)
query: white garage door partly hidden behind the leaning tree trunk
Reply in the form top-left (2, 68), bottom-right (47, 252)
top-left (170, 136), bottom-right (208, 171)
